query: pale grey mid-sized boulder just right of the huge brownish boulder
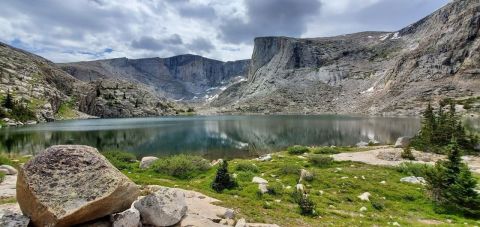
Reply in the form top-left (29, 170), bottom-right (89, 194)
top-left (133, 187), bottom-right (187, 226)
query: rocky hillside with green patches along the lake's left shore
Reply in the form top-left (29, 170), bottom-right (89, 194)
top-left (0, 43), bottom-right (181, 121)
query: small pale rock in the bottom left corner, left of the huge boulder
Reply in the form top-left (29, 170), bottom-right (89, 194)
top-left (0, 203), bottom-right (30, 227)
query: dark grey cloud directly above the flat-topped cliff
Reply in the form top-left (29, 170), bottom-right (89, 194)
top-left (220, 0), bottom-right (321, 43)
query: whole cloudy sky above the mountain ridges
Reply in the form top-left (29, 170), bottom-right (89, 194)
top-left (0, 0), bottom-right (450, 62)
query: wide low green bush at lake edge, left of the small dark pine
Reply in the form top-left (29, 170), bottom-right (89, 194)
top-left (151, 154), bottom-right (210, 179)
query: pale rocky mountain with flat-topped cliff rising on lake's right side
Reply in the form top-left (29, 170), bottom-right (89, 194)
top-left (211, 0), bottom-right (480, 115)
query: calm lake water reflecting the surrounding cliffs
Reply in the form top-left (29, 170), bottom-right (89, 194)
top-left (0, 115), bottom-right (420, 159)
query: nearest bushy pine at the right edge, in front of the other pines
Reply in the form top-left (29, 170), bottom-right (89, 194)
top-left (426, 140), bottom-right (480, 217)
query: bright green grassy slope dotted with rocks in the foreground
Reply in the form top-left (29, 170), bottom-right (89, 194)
top-left (115, 149), bottom-right (480, 226)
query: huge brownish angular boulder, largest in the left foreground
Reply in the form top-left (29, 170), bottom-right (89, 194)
top-left (17, 145), bottom-right (139, 226)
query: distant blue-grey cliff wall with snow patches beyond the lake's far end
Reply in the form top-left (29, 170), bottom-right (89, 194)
top-left (59, 55), bottom-right (249, 102)
